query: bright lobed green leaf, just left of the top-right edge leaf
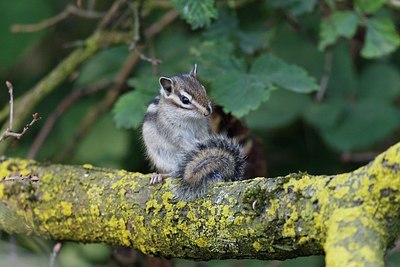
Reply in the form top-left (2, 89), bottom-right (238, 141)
top-left (318, 11), bottom-right (359, 50)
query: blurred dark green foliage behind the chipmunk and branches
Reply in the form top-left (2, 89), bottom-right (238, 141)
top-left (0, 0), bottom-right (400, 266)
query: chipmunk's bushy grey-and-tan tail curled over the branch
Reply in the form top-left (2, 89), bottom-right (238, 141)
top-left (174, 135), bottom-right (245, 201)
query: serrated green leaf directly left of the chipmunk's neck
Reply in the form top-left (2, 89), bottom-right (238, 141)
top-left (113, 91), bottom-right (154, 129)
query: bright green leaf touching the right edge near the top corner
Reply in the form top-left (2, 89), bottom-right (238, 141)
top-left (361, 18), bottom-right (400, 58)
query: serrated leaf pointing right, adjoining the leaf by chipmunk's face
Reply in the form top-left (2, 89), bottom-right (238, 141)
top-left (250, 55), bottom-right (318, 93)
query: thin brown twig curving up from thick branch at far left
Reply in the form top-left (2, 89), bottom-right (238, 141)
top-left (27, 82), bottom-right (110, 159)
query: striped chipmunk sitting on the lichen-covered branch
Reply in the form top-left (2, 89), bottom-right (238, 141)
top-left (142, 65), bottom-right (245, 201)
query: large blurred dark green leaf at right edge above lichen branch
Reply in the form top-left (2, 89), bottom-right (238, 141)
top-left (322, 99), bottom-right (400, 152)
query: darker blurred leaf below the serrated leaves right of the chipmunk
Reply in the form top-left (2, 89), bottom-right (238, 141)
top-left (245, 89), bottom-right (311, 129)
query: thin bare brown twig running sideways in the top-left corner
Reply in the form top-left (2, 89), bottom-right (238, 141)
top-left (11, 4), bottom-right (106, 32)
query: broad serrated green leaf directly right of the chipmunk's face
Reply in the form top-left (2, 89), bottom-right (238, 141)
top-left (212, 71), bottom-right (272, 118)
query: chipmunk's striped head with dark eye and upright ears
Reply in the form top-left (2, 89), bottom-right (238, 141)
top-left (159, 65), bottom-right (212, 118)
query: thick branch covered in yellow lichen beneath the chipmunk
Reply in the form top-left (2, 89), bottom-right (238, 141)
top-left (0, 143), bottom-right (400, 266)
